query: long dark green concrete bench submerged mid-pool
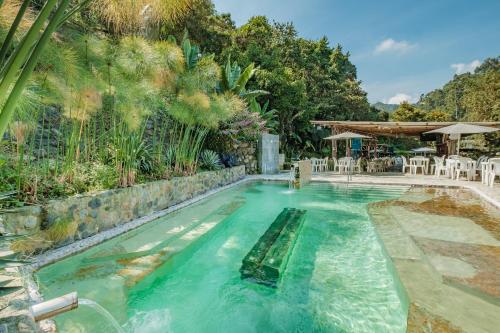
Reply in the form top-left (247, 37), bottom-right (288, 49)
top-left (240, 208), bottom-right (306, 288)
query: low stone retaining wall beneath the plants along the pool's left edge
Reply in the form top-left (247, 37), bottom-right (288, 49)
top-left (0, 166), bottom-right (245, 251)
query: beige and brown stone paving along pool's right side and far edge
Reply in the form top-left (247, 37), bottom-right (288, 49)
top-left (292, 173), bottom-right (500, 333)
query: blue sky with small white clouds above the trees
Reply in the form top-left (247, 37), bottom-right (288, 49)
top-left (213, 0), bottom-right (500, 103)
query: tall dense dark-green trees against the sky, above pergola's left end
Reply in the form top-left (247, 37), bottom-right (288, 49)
top-left (223, 16), bottom-right (370, 155)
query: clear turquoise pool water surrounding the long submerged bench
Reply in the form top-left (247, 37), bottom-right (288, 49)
top-left (36, 183), bottom-right (407, 333)
